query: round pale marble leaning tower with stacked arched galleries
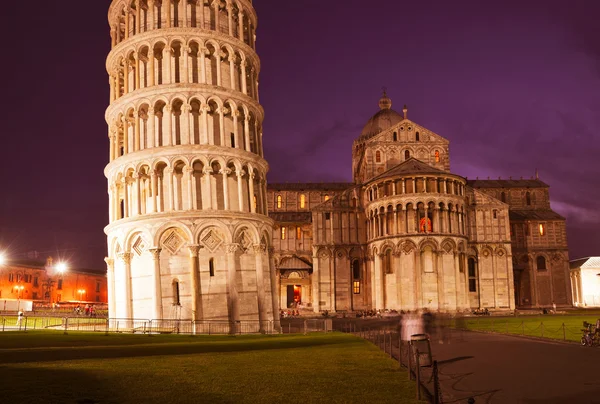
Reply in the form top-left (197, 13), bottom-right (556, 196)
top-left (105, 0), bottom-right (278, 328)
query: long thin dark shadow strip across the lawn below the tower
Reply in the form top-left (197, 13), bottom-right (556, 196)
top-left (0, 335), bottom-right (363, 364)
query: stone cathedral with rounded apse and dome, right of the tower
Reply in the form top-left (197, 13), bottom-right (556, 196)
top-left (267, 94), bottom-right (571, 312)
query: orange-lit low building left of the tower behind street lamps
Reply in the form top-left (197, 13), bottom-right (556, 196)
top-left (0, 258), bottom-right (107, 304)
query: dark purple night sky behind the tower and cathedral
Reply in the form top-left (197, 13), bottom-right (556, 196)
top-left (0, 0), bottom-right (600, 269)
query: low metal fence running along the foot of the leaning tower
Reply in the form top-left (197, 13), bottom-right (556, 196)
top-left (0, 316), bottom-right (332, 335)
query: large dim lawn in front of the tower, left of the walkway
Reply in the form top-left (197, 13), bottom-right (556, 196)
top-left (0, 332), bottom-right (416, 403)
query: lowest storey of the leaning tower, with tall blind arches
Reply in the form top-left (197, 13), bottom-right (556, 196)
top-left (106, 212), bottom-right (279, 332)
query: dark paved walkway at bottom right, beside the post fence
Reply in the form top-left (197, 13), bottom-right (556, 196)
top-left (432, 331), bottom-right (600, 404)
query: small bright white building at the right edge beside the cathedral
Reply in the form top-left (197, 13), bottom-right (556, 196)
top-left (571, 257), bottom-right (600, 307)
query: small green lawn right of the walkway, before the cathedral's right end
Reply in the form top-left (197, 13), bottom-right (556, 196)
top-left (455, 312), bottom-right (600, 342)
